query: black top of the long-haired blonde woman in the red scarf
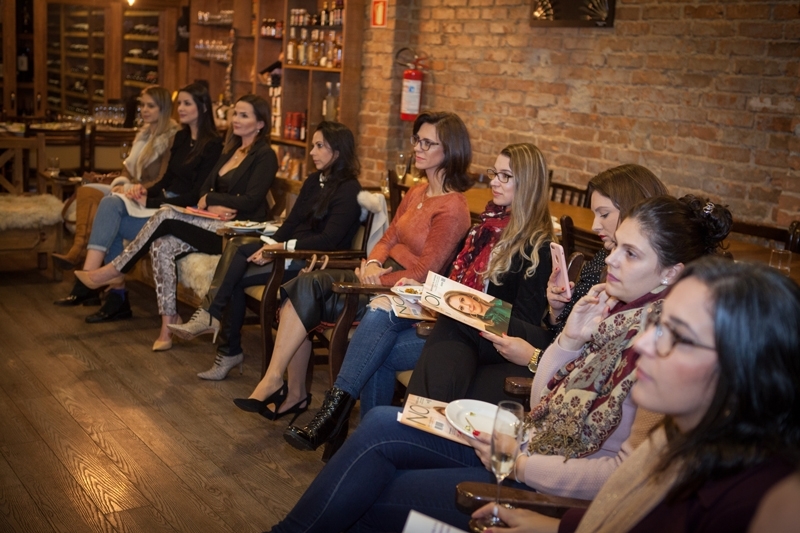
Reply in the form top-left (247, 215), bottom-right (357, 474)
top-left (486, 241), bottom-right (553, 348)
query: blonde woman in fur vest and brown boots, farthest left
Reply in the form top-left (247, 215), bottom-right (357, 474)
top-left (52, 85), bottom-right (180, 274)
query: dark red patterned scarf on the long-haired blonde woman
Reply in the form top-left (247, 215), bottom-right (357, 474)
top-left (450, 202), bottom-right (510, 291)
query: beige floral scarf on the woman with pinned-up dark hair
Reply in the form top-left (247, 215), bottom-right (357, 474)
top-left (527, 286), bottom-right (666, 458)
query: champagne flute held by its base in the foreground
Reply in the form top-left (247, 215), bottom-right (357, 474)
top-left (470, 401), bottom-right (525, 531)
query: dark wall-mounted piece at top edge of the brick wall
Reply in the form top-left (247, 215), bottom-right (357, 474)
top-left (531, 0), bottom-right (616, 28)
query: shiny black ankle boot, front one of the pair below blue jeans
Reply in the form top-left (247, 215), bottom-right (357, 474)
top-left (283, 387), bottom-right (356, 451)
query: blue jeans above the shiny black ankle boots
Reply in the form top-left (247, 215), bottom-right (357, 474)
top-left (333, 307), bottom-right (425, 418)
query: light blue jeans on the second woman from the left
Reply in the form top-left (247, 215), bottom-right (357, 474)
top-left (86, 194), bottom-right (148, 263)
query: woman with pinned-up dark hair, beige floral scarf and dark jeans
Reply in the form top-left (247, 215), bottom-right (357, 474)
top-left (262, 196), bottom-right (732, 533)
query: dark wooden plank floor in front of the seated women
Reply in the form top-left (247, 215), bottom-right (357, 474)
top-left (0, 256), bottom-right (340, 533)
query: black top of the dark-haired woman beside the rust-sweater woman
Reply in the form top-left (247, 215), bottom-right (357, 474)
top-left (272, 172), bottom-right (361, 251)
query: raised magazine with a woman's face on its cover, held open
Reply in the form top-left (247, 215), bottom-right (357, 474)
top-left (419, 272), bottom-right (511, 335)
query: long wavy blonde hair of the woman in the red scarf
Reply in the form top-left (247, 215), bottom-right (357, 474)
top-left (483, 143), bottom-right (555, 285)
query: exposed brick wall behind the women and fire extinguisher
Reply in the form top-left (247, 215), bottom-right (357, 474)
top-left (358, 0), bottom-right (800, 225)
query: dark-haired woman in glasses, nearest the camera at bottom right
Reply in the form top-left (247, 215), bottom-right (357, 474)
top-left (475, 258), bottom-right (800, 533)
